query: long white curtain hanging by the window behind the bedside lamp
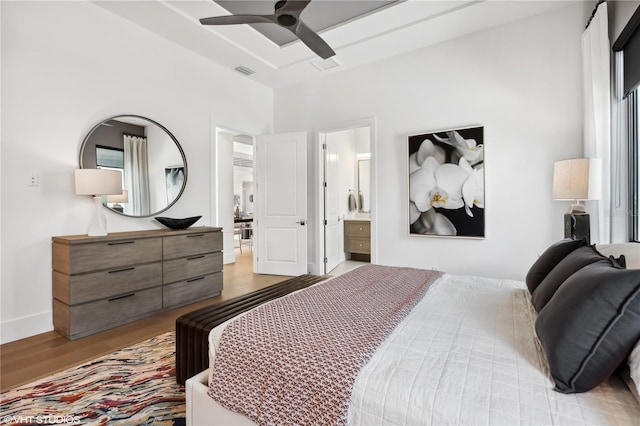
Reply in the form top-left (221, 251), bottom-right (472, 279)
top-left (582, 2), bottom-right (611, 244)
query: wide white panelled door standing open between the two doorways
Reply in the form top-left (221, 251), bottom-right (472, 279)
top-left (254, 132), bottom-right (308, 276)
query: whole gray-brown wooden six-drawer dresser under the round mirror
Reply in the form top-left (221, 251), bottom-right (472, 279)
top-left (52, 227), bottom-right (222, 340)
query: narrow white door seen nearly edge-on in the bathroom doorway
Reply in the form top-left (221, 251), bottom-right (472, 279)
top-left (324, 138), bottom-right (344, 274)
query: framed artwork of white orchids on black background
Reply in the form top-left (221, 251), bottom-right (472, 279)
top-left (408, 126), bottom-right (485, 238)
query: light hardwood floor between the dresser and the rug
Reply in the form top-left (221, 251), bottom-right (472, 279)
top-left (0, 250), bottom-right (291, 392)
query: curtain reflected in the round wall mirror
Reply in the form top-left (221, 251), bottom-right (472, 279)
top-left (124, 134), bottom-right (151, 216)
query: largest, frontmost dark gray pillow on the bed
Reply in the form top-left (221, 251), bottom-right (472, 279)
top-left (535, 258), bottom-right (640, 393)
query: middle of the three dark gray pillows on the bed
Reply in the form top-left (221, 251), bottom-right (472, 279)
top-left (531, 246), bottom-right (606, 312)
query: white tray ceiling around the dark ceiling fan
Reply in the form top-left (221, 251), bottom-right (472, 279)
top-left (94, 0), bottom-right (576, 88)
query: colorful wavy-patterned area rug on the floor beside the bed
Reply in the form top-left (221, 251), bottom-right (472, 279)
top-left (0, 331), bottom-right (185, 425)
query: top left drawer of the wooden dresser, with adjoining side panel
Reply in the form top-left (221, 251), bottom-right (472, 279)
top-left (53, 238), bottom-right (162, 275)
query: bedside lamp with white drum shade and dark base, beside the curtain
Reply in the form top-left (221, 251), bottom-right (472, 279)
top-left (553, 158), bottom-right (602, 242)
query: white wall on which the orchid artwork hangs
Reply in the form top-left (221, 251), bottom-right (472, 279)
top-left (274, 4), bottom-right (590, 279)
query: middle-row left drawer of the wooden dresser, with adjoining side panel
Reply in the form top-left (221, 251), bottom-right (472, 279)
top-left (53, 262), bottom-right (162, 305)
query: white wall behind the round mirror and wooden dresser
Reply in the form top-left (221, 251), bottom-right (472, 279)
top-left (0, 1), bottom-right (273, 343)
